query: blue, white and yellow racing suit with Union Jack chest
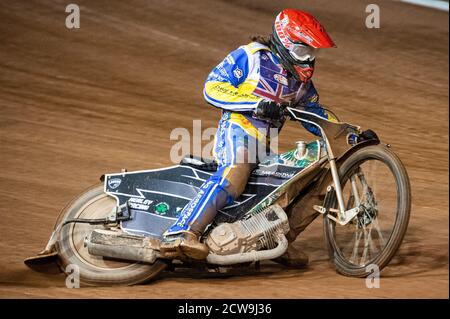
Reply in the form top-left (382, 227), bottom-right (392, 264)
top-left (165, 42), bottom-right (330, 236)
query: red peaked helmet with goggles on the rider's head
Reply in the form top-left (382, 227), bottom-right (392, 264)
top-left (271, 9), bottom-right (336, 82)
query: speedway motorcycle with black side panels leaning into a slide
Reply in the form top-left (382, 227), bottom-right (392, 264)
top-left (25, 107), bottom-right (411, 285)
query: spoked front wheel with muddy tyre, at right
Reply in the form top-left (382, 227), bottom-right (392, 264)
top-left (324, 145), bottom-right (411, 277)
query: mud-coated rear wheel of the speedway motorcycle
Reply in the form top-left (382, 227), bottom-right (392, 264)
top-left (56, 184), bottom-right (167, 285)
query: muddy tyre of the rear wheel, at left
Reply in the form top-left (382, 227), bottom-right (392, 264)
top-left (55, 184), bottom-right (167, 286)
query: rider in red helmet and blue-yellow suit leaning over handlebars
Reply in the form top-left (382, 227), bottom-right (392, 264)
top-left (160, 9), bottom-right (336, 266)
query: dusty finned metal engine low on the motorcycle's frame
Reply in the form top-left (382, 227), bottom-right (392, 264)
top-left (206, 204), bottom-right (289, 256)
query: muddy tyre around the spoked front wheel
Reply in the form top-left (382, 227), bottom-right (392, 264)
top-left (323, 144), bottom-right (411, 277)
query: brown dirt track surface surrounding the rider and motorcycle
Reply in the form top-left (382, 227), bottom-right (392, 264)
top-left (0, 0), bottom-right (449, 298)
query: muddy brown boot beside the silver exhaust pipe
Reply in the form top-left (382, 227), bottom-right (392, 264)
top-left (159, 231), bottom-right (209, 260)
